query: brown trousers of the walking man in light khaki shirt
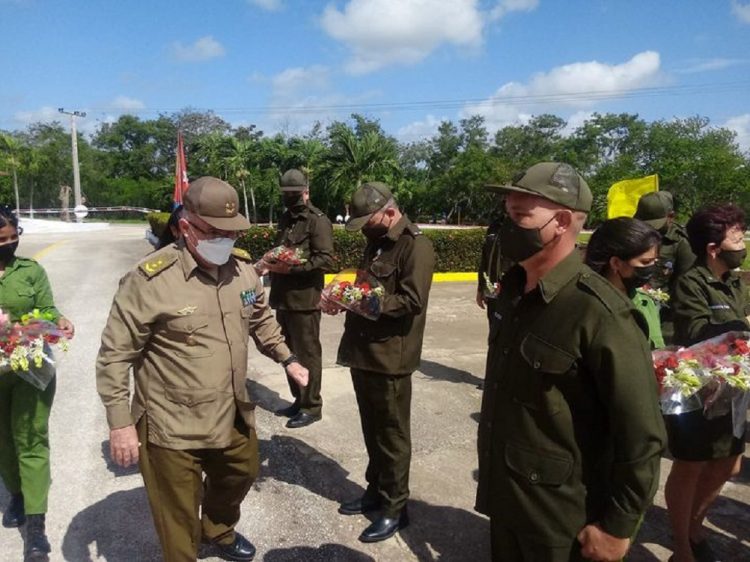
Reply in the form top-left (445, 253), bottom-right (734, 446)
top-left (137, 415), bottom-right (260, 562)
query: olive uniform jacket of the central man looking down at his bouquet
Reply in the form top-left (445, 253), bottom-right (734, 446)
top-left (337, 216), bottom-right (435, 375)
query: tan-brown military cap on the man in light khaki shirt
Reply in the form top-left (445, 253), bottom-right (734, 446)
top-left (183, 176), bottom-right (250, 230)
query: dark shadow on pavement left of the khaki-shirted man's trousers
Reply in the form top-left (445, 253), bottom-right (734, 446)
top-left (62, 487), bottom-right (161, 562)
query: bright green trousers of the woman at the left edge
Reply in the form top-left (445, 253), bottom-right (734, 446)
top-left (0, 373), bottom-right (56, 515)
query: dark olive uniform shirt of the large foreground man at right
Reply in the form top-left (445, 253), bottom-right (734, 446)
top-left (476, 251), bottom-right (665, 547)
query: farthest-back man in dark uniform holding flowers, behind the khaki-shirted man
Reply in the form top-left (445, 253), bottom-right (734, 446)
top-left (259, 170), bottom-right (334, 428)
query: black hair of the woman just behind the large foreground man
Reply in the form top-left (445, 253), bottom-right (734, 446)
top-left (586, 217), bottom-right (661, 275)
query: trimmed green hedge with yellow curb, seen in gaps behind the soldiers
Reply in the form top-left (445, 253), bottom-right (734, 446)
top-left (146, 213), bottom-right (485, 272)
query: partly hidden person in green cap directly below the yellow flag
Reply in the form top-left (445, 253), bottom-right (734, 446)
top-left (633, 191), bottom-right (695, 345)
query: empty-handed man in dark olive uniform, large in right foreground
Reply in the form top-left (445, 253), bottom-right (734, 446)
top-left (476, 162), bottom-right (664, 562)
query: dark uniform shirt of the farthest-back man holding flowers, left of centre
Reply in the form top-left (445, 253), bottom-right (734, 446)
top-left (269, 204), bottom-right (334, 310)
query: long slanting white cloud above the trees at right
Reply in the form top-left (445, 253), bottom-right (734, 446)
top-left (461, 51), bottom-right (664, 130)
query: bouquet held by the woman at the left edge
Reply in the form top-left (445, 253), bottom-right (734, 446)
top-left (0, 309), bottom-right (67, 390)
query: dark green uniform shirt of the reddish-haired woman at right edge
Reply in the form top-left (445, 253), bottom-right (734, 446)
top-left (671, 261), bottom-right (749, 345)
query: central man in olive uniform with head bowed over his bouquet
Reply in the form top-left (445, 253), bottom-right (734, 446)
top-left (322, 182), bottom-right (435, 542)
